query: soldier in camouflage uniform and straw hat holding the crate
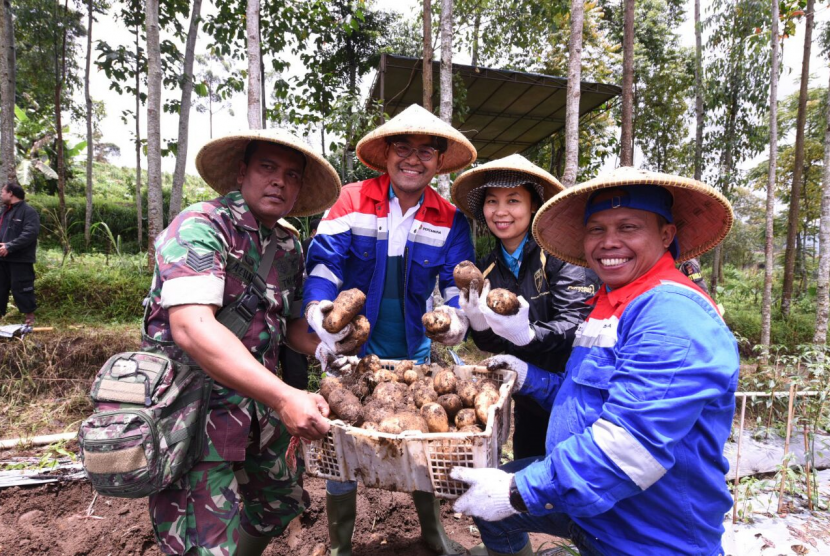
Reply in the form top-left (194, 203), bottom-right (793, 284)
top-left (143, 130), bottom-right (340, 556)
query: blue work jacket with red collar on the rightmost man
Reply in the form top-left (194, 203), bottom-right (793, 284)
top-left (516, 253), bottom-right (739, 556)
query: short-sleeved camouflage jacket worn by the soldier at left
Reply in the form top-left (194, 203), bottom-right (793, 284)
top-left (142, 191), bottom-right (304, 461)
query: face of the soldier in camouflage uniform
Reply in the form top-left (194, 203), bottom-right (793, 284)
top-left (236, 142), bottom-right (305, 228)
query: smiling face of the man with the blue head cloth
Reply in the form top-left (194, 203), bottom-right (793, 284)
top-left (583, 207), bottom-right (677, 289)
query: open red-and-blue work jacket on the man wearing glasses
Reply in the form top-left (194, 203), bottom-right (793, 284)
top-left (303, 174), bottom-right (475, 358)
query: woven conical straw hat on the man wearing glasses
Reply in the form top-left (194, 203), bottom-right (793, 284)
top-left (356, 104), bottom-right (478, 174)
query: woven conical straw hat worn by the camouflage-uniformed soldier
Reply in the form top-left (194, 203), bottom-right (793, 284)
top-left (196, 129), bottom-right (340, 216)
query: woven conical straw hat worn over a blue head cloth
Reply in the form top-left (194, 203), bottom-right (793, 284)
top-left (533, 166), bottom-right (734, 266)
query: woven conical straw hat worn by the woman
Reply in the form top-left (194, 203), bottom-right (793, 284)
top-left (451, 154), bottom-right (565, 222)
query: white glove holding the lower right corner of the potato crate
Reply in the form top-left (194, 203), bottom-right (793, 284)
top-left (450, 467), bottom-right (519, 521)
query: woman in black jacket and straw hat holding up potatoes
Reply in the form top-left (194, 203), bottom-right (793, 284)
top-left (452, 154), bottom-right (599, 459)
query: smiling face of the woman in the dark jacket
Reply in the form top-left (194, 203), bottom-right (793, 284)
top-left (482, 187), bottom-right (539, 253)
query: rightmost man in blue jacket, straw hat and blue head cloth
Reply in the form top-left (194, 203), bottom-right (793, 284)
top-left (452, 168), bottom-right (738, 556)
